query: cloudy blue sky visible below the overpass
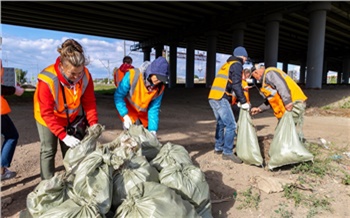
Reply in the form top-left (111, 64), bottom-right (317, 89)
top-left (1, 24), bottom-right (238, 81)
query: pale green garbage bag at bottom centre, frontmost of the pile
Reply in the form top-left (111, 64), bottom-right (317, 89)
top-left (114, 182), bottom-right (200, 218)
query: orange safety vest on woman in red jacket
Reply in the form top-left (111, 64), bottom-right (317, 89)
top-left (34, 64), bottom-right (91, 126)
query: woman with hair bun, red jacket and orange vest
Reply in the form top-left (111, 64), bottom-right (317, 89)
top-left (34, 39), bottom-right (98, 179)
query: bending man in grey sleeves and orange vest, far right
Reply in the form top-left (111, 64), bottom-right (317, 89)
top-left (251, 65), bottom-right (307, 140)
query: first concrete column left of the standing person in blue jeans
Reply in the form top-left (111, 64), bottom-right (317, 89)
top-left (205, 31), bottom-right (218, 88)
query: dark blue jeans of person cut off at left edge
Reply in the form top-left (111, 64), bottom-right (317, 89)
top-left (1, 114), bottom-right (19, 167)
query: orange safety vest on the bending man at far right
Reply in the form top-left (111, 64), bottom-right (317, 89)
top-left (260, 67), bottom-right (307, 119)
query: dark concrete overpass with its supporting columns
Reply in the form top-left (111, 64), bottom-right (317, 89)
top-left (1, 1), bottom-right (350, 88)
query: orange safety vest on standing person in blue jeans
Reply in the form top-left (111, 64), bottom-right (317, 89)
top-left (208, 61), bottom-right (237, 100)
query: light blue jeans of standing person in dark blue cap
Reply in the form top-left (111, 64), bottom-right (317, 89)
top-left (209, 98), bottom-right (237, 155)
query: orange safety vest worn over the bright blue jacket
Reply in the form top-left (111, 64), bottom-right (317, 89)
top-left (125, 68), bottom-right (165, 127)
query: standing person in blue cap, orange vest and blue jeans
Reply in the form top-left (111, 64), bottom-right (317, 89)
top-left (208, 46), bottom-right (250, 163)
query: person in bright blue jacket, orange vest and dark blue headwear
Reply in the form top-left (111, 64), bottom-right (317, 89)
top-left (114, 56), bottom-right (169, 136)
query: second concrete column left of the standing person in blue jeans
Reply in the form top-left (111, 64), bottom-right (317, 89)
top-left (185, 37), bottom-right (195, 88)
